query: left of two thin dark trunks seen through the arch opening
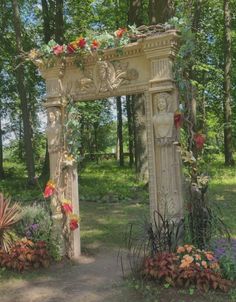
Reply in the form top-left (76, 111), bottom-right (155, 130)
top-left (116, 96), bottom-right (124, 167)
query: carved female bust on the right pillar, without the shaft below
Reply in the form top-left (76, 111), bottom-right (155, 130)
top-left (153, 93), bottom-right (174, 139)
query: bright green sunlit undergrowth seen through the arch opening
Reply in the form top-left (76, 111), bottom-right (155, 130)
top-left (79, 160), bottom-right (148, 202)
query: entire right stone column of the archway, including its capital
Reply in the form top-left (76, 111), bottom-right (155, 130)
top-left (144, 36), bottom-right (183, 220)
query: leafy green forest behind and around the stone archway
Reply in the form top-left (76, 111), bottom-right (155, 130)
top-left (0, 0), bottom-right (236, 196)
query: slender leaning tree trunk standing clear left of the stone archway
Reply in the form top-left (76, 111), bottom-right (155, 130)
top-left (12, 0), bottom-right (35, 184)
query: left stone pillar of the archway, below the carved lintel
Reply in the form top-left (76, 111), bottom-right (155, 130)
top-left (45, 97), bottom-right (81, 259)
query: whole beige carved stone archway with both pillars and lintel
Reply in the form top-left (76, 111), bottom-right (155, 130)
top-left (39, 30), bottom-right (183, 258)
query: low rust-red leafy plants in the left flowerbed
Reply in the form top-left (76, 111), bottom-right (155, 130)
top-left (0, 238), bottom-right (50, 272)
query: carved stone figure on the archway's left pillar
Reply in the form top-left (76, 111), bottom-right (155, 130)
top-left (46, 107), bottom-right (62, 153)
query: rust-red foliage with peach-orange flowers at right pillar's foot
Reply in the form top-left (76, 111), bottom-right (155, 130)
top-left (143, 244), bottom-right (232, 292)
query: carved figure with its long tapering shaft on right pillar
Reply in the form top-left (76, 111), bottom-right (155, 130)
top-left (153, 92), bottom-right (181, 217)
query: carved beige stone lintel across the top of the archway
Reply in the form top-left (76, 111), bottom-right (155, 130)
top-left (40, 31), bottom-right (179, 100)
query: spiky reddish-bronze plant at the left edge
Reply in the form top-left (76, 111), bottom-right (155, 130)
top-left (0, 193), bottom-right (22, 252)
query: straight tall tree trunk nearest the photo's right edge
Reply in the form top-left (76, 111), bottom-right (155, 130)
top-left (223, 0), bottom-right (234, 166)
